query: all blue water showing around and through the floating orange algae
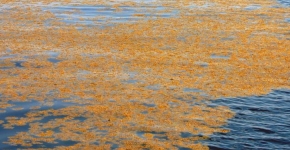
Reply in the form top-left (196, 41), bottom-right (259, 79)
top-left (0, 0), bottom-right (290, 150)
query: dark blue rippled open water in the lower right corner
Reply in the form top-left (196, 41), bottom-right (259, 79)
top-left (205, 89), bottom-right (290, 150)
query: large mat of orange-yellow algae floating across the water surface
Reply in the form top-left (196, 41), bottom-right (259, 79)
top-left (0, 0), bottom-right (290, 149)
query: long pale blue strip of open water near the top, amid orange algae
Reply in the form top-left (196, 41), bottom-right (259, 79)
top-left (43, 5), bottom-right (178, 26)
